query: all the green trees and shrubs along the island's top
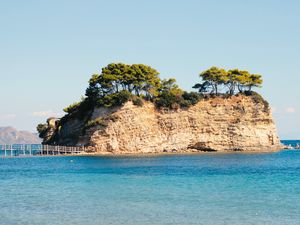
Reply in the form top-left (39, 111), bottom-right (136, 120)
top-left (64, 63), bottom-right (263, 118)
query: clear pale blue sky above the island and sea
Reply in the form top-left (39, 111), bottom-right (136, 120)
top-left (0, 0), bottom-right (300, 138)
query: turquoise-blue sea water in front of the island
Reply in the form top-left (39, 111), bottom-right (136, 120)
top-left (0, 141), bottom-right (300, 225)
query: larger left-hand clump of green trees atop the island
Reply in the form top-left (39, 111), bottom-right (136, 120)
top-left (61, 63), bottom-right (161, 122)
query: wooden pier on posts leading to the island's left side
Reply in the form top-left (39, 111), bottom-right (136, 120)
top-left (0, 144), bottom-right (86, 157)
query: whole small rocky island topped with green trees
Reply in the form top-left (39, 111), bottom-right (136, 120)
top-left (37, 63), bottom-right (282, 154)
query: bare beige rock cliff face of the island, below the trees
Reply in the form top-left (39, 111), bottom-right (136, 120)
top-left (44, 96), bottom-right (282, 154)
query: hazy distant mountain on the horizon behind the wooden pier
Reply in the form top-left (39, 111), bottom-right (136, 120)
top-left (0, 127), bottom-right (41, 144)
